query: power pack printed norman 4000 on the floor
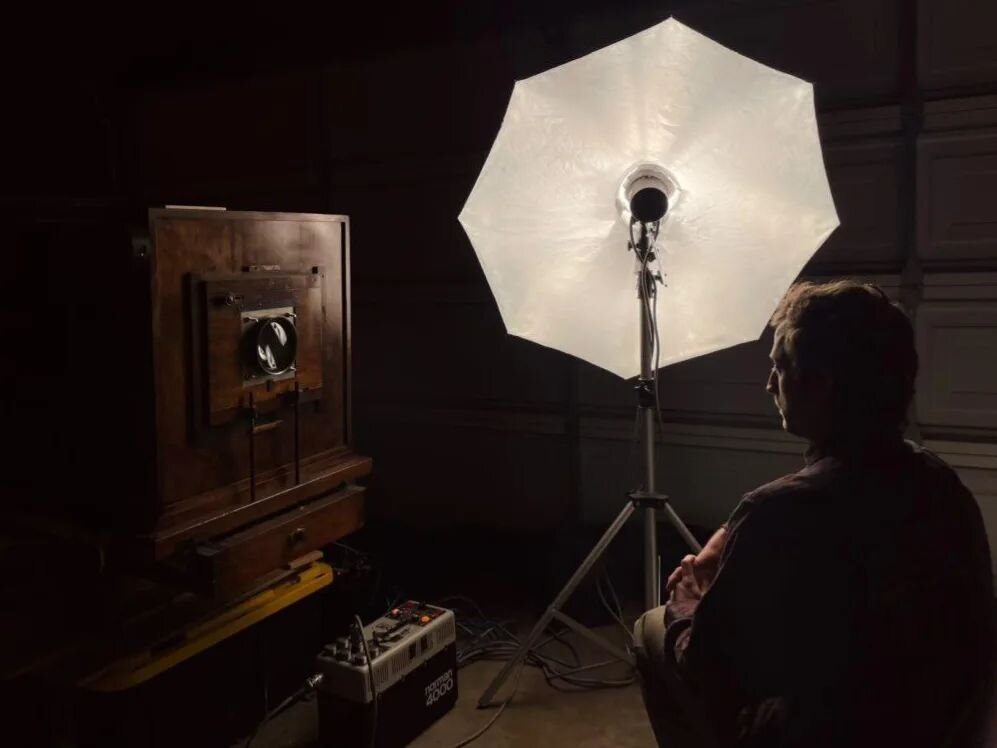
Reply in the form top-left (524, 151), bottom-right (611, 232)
top-left (318, 600), bottom-right (457, 748)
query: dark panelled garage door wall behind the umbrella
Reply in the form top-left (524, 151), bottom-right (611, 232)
top-left (0, 0), bottom-right (997, 572)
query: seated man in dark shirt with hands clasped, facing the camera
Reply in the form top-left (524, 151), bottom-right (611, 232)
top-left (634, 281), bottom-right (997, 748)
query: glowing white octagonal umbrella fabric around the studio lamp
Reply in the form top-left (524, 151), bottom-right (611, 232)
top-left (460, 19), bottom-right (838, 378)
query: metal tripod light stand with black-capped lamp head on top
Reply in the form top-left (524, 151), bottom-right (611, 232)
top-left (478, 193), bottom-right (702, 708)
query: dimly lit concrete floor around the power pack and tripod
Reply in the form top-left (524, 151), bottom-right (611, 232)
top-left (233, 626), bottom-right (656, 748)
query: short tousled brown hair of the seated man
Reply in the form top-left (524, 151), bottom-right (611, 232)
top-left (769, 280), bottom-right (918, 429)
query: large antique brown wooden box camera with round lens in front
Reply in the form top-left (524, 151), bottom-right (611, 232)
top-left (130, 208), bottom-right (371, 593)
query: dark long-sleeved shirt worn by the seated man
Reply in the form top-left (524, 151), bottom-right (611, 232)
top-left (666, 436), bottom-right (995, 748)
